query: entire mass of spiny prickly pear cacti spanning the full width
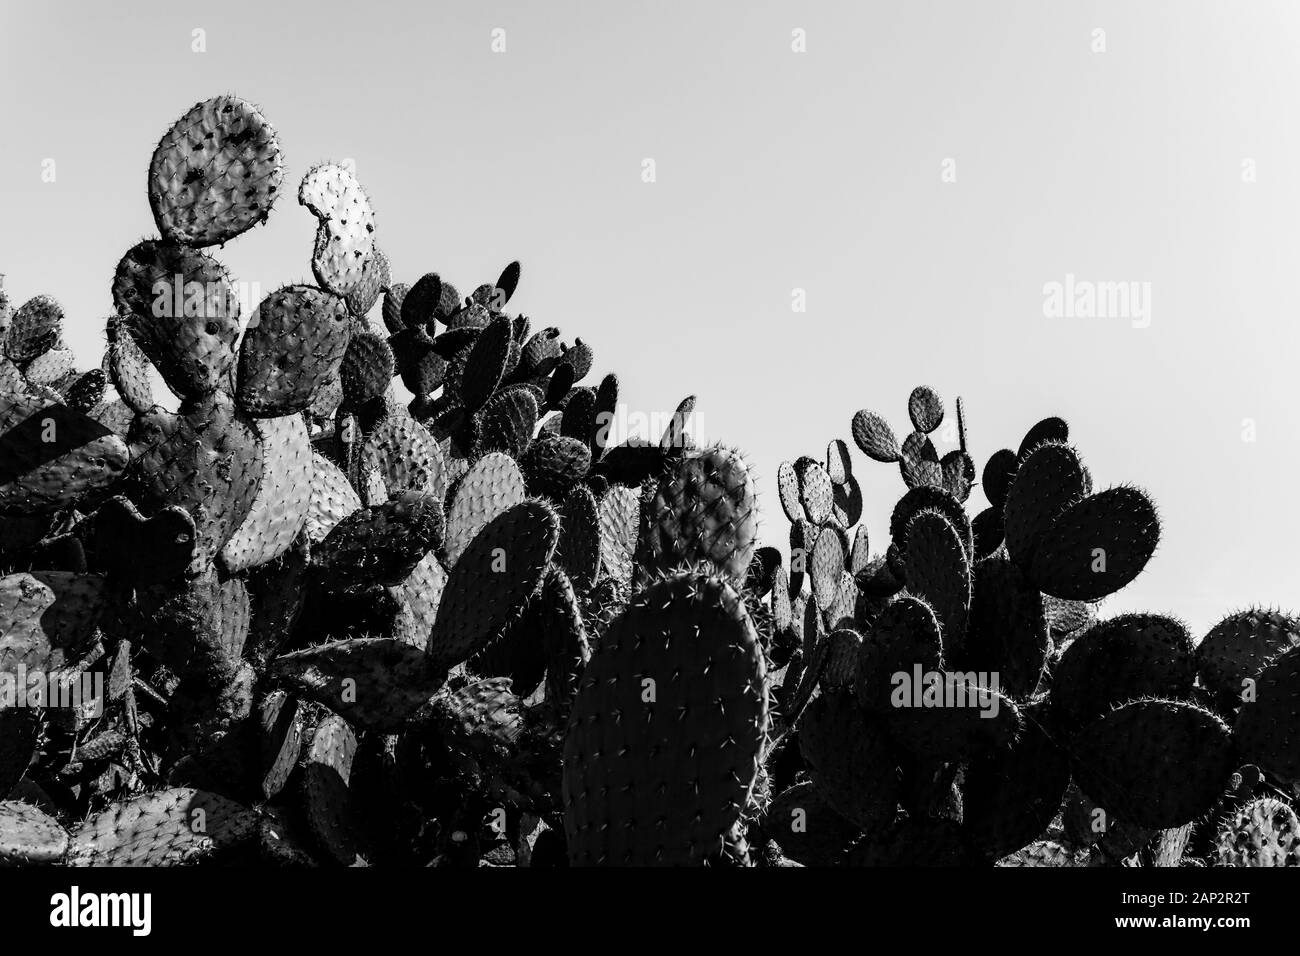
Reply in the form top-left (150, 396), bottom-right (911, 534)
top-left (0, 96), bottom-right (1300, 866)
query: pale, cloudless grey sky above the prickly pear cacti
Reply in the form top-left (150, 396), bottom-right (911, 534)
top-left (0, 0), bottom-right (1300, 636)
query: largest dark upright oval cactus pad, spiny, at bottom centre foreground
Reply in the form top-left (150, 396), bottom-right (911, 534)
top-left (564, 574), bottom-right (767, 866)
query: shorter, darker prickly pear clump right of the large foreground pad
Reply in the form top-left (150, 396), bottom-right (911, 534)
top-left (757, 386), bottom-right (1300, 866)
